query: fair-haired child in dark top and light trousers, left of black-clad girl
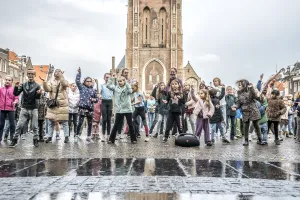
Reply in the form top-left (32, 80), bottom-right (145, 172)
top-left (153, 82), bottom-right (168, 138)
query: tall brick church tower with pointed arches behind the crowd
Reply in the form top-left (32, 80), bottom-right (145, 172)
top-left (125, 0), bottom-right (183, 92)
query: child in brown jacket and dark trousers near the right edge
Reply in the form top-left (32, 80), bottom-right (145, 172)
top-left (267, 89), bottom-right (287, 145)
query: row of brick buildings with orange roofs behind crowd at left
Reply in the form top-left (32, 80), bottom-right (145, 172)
top-left (0, 48), bottom-right (51, 87)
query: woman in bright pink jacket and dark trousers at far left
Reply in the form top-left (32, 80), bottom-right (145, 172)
top-left (0, 76), bottom-right (19, 142)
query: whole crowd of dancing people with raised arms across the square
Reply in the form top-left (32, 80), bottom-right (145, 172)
top-left (0, 68), bottom-right (300, 147)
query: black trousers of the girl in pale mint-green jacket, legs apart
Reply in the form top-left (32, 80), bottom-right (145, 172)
top-left (109, 113), bottom-right (136, 143)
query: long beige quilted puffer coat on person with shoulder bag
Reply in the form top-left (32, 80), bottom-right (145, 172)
top-left (43, 77), bottom-right (69, 121)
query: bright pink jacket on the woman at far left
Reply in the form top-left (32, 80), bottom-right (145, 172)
top-left (0, 85), bottom-right (19, 111)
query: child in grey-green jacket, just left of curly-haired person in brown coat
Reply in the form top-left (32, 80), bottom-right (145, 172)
top-left (225, 86), bottom-right (237, 140)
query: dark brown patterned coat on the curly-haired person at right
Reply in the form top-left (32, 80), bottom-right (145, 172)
top-left (236, 87), bottom-right (261, 122)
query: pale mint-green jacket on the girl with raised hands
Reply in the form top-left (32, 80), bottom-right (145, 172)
top-left (107, 78), bottom-right (132, 113)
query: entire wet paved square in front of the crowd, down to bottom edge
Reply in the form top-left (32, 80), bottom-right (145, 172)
top-left (0, 132), bottom-right (300, 200)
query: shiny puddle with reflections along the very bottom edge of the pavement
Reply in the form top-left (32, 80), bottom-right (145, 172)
top-left (31, 192), bottom-right (296, 200)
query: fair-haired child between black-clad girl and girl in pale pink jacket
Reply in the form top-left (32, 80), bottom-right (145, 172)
top-left (183, 83), bottom-right (198, 134)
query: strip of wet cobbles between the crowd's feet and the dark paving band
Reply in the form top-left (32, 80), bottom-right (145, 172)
top-left (0, 131), bottom-right (300, 162)
